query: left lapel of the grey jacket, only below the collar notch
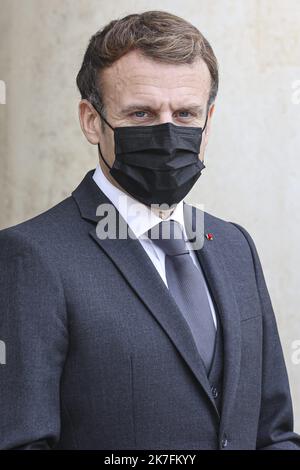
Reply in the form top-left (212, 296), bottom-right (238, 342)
top-left (90, 228), bottom-right (217, 411)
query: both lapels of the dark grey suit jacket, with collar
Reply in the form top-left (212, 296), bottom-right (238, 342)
top-left (72, 170), bottom-right (241, 426)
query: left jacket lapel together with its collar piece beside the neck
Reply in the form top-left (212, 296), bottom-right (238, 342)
top-left (72, 170), bottom-right (219, 416)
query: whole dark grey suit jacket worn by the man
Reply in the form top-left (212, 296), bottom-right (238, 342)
top-left (0, 170), bottom-right (300, 450)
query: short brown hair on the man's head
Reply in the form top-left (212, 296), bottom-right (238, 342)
top-left (77, 10), bottom-right (219, 121)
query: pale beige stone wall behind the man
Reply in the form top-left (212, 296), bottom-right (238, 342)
top-left (0, 0), bottom-right (300, 432)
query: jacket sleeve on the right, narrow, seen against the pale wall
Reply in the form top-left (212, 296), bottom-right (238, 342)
top-left (234, 224), bottom-right (300, 450)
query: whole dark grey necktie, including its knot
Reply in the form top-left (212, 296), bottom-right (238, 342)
top-left (148, 220), bottom-right (216, 373)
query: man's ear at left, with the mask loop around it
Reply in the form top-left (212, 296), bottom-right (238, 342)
top-left (78, 99), bottom-right (101, 145)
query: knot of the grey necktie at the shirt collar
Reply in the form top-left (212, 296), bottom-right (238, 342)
top-left (147, 220), bottom-right (189, 256)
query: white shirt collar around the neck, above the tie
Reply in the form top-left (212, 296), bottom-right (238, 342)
top-left (93, 163), bottom-right (187, 239)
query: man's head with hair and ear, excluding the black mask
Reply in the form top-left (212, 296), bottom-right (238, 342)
top-left (77, 11), bottom-right (218, 196)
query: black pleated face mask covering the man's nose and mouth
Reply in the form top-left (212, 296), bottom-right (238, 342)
top-left (98, 111), bottom-right (208, 206)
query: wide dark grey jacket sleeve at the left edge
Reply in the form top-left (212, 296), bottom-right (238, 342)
top-left (0, 228), bottom-right (67, 449)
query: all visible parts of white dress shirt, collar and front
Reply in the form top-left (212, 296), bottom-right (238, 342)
top-left (93, 163), bottom-right (217, 326)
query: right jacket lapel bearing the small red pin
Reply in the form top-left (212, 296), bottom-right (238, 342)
top-left (184, 203), bottom-right (241, 434)
